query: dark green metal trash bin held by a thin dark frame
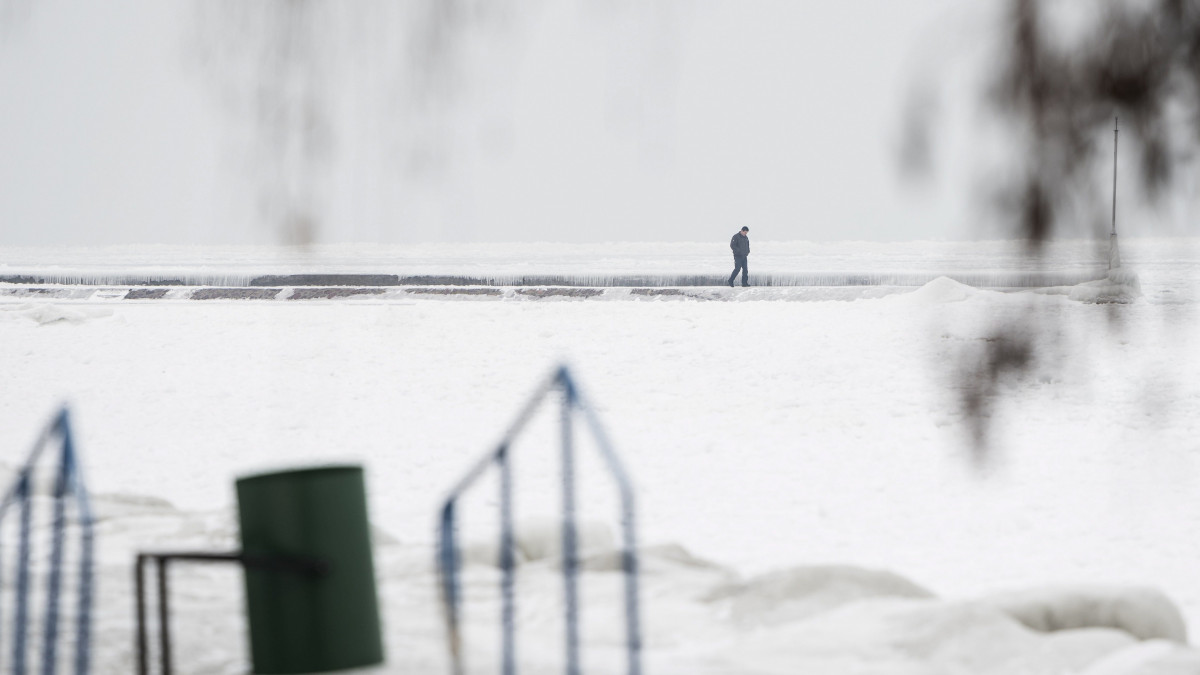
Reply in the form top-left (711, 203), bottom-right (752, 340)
top-left (238, 466), bottom-right (383, 675)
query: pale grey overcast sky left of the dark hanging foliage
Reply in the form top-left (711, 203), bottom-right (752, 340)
top-left (0, 0), bottom-right (1099, 245)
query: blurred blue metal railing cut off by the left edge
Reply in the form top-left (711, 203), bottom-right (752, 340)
top-left (0, 407), bottom-right (95, 675)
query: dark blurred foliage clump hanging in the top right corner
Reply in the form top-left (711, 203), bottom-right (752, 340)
top-left (990, 0), bottom-right (1200, 246)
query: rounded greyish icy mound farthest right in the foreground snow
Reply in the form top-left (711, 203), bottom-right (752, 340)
top-left (983, 586), bottom-right (1188, 643)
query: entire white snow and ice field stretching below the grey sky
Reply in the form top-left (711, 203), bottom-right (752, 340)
top-left (0, 239), bottom-right (1200, 675)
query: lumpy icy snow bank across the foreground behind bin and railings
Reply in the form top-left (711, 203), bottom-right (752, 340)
top-left (16, 494), bottom-right (1200, 675)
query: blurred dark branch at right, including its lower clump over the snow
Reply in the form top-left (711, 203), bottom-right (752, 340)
top-left (936, 0), bottom-right (1200, 465)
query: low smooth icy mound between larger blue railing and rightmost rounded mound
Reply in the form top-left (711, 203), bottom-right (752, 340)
top-left (712, 565), bottom-right (934, 625)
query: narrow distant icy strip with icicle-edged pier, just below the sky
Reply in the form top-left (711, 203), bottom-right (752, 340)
top-left (0, 238), bottom-right (1200, 298)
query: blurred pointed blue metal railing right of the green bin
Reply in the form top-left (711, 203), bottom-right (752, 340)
top-left (438, 366), bottom-right (642, 675)
